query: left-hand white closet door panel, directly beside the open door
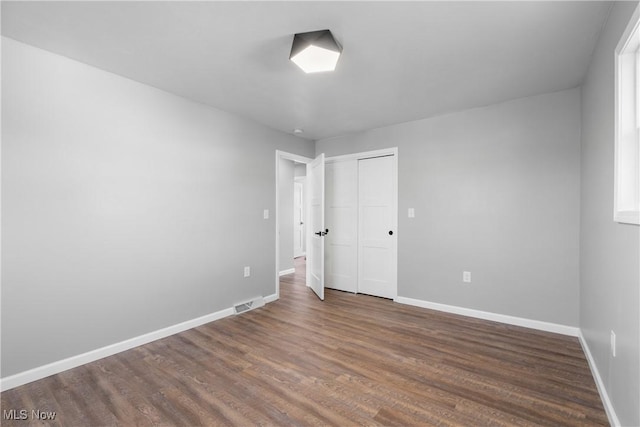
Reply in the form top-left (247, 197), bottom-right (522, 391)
top-left (325, 159), bottom-right (358, 293)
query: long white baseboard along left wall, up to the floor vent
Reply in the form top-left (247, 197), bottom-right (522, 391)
top-left (0, 306), bottom-right (238, 391)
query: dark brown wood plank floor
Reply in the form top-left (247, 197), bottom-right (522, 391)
top-left (1, 265), bottom-right (608, 426)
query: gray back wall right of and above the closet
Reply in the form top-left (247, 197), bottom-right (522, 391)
top-left (316, 89), bottom-right (580, 326)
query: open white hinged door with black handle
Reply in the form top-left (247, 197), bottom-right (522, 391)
top-left (306, 154), bottom-right (327, 300)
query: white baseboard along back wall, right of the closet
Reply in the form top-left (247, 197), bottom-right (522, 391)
top-left (394, 297), bottom-right (580, 337)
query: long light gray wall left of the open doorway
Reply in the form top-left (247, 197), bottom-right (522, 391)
top-left (2, 39), bottom-right (313, 377)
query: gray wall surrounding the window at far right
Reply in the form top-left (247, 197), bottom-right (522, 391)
top-left (580, 2), bottom-right (640, 426)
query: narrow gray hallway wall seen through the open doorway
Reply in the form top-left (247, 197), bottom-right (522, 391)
top-left (278, 159), bottom-right (294, 271)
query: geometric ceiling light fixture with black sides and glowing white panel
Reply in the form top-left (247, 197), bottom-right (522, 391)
top-left (289, 30), bottom-right (342, 73)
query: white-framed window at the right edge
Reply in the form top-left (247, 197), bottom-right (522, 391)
top-left (613, 6), bottom-right (640, 224)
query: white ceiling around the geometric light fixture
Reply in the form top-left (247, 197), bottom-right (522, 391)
top-left (2, 1), bottom-right (610, 139)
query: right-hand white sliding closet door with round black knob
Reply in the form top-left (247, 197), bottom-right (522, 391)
top-left (358, 156), bottom-right (398, 298)
